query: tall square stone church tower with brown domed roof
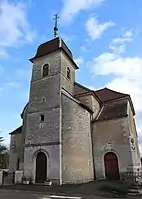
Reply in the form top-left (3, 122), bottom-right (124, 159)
top-left (24, 37), bottom-right (78, 184)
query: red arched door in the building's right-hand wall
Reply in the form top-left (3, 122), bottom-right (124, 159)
top-left (104, 152), bottom-right (120, 180)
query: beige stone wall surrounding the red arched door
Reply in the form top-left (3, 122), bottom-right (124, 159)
top-left (92, 117), bottom-right (136, 178)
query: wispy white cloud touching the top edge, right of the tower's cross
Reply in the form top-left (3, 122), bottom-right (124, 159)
top-left (60, 0), bottom-right (105, 23)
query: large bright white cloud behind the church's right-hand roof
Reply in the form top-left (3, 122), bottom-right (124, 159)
top-left (91, 30), bottom-right (142, 153)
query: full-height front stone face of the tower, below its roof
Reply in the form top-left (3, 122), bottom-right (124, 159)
top-left (24, 51), bottom-right (61, 183)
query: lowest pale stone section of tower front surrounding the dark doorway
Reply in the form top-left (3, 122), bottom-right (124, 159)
top-left (24, 144), bottom-right (60, 184)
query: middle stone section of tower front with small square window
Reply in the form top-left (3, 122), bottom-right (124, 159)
top-left (25, 108), bottom-right (61, 145)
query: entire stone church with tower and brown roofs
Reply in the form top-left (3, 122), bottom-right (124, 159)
top-left (9, 37), bottom-right (141, 184)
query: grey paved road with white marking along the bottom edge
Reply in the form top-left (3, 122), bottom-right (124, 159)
top-left (0, 189), bottom-right (106, 199)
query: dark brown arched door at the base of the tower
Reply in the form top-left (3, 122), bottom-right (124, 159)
top-left (36, 152), bottom-right (47, 183)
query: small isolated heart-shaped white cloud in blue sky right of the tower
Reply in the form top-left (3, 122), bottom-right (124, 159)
top-left (86, 17), bottom-right (115, 40)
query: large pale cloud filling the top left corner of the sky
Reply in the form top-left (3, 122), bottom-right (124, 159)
top-left (0, 0), bottom-right (35, 47)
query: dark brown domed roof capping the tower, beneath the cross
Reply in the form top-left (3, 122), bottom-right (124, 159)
top-left (30, 37), bottom-right (78, 69)
